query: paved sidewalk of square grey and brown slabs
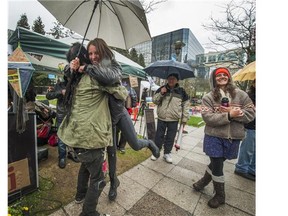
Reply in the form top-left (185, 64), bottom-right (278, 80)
top-left (51, 124), bottom-right (255, 216)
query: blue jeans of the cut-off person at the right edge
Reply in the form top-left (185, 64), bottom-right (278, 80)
top-left (235, 129), bottom-right (256, 175)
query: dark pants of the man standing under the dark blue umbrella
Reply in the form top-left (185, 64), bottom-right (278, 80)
top-left (155, 119), bottom-right (178, 154)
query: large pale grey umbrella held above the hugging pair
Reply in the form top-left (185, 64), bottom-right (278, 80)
top-left (38, 0), bottom-right (151, 49)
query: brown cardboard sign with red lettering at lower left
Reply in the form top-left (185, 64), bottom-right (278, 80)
top-left (8, 158), bottom-right (31, 193)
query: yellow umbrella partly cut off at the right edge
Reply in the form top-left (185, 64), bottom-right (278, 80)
top-left (232, 61), bottom-right (256, 82)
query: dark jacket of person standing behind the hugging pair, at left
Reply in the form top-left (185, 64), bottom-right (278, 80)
top-left (46, 82), bottom-right (66, 119)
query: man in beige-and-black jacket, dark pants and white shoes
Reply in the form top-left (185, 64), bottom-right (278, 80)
top-left (151, 73), bottom-right (189, 163)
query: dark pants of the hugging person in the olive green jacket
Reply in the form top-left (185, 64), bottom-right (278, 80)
top-left (75, 148), bottom-right (106, 216)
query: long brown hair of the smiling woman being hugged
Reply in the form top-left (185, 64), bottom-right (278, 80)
top-left (87, 38), bottom-right (114, 61)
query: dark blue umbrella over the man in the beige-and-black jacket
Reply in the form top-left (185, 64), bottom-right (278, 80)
top-left (144, 60), bottom-right (195, 80)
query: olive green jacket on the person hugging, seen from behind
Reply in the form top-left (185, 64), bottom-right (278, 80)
top-left (58, 74), bottom-right (119, 149)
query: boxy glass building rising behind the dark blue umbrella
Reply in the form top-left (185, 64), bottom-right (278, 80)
top-left (134, 28), bottom-right (204, 66)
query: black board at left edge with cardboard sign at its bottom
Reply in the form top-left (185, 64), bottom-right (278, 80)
top-left (6, 112), bottom-right (39, 203)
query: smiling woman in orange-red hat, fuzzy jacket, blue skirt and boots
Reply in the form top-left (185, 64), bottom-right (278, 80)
top-left (193, 67), bottom-right (255, 208)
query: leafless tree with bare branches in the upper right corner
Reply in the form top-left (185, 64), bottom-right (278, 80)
top-left (203, 0), bottom-right (256, 63)
